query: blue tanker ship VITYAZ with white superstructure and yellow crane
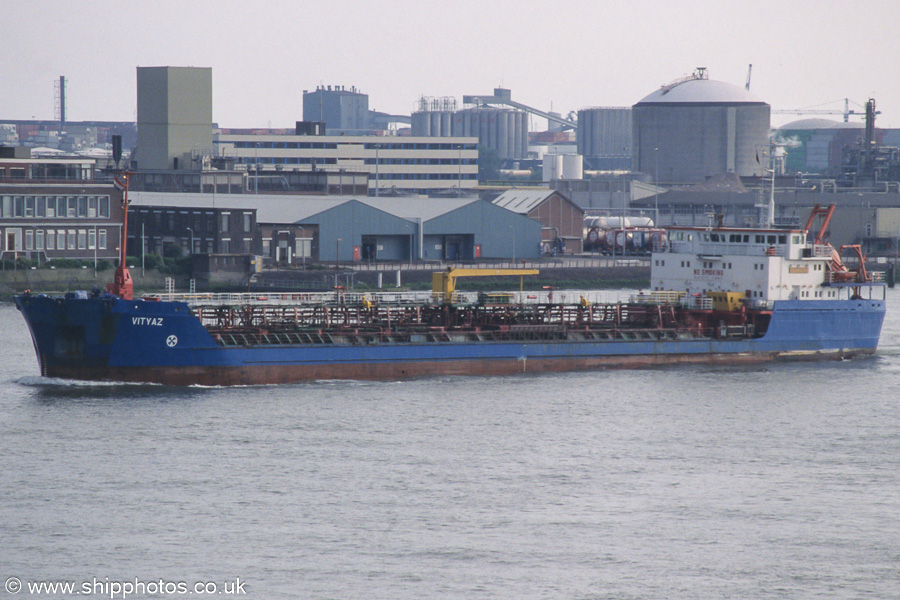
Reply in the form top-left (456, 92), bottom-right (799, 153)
top-left (15, 179), bottom-right (885, 386)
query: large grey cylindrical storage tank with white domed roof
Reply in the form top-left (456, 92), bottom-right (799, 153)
top-left (632, 69), bottom-right (771, 183)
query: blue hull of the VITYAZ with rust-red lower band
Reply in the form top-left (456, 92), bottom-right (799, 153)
top-left (15, 295), bottom-right (885, 385)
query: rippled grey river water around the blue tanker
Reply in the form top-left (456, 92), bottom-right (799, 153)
top-left (0, 290), bottom-right (900, 599)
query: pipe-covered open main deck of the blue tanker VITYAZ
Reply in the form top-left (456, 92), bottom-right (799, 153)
top-left (172, 294), bottom-right (770, 347)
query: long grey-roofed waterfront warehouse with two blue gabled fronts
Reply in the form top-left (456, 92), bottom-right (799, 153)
top-left (129, 192), bottom-right (541, 264)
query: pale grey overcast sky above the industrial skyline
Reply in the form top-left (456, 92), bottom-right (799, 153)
top-left (0, 0), bottom-right (900, 128)
